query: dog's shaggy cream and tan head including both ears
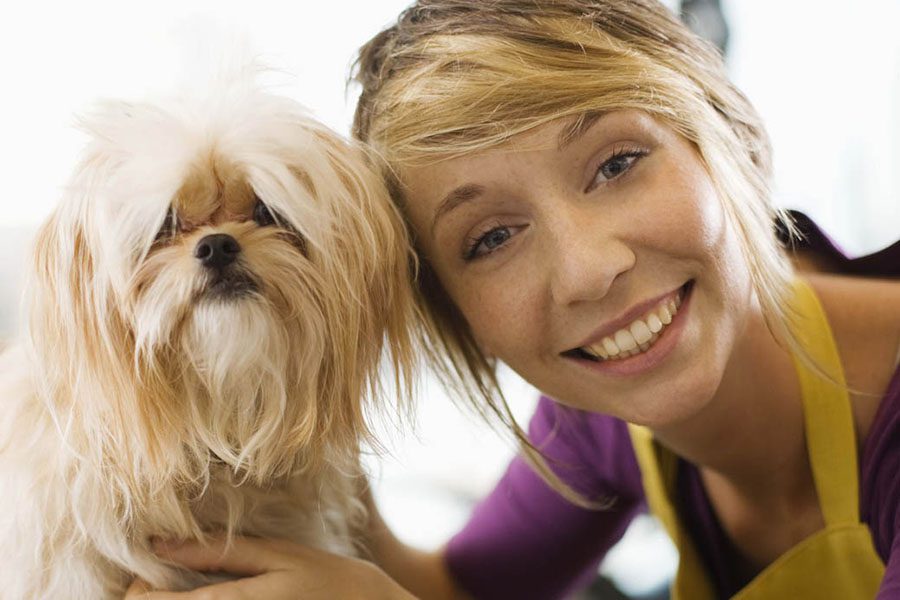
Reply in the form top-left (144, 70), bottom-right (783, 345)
top-left (29, 86), bottom-right (412, 488)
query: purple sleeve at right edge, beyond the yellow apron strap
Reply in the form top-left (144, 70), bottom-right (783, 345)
top-left (860, 368), bottom-right (900, 600)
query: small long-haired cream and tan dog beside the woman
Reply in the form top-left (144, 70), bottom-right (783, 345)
top-left (0, 65), bottom-right (414, 600)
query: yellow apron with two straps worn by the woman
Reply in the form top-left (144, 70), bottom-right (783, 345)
top-left (629, 280), bottom-right (884, 600)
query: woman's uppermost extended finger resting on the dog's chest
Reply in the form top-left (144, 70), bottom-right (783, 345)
top-left (153, 537), bottom-right (288, 577)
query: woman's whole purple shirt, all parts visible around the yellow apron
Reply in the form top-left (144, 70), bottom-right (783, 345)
top-left (446, 213), bottom-right (900, 600)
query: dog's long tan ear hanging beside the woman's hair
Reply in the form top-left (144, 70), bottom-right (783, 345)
top-left (292, 136), bottom-right (417, 454)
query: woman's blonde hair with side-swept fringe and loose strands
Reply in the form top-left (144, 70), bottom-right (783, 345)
top-left (354, 0), bottom-right (802, 506)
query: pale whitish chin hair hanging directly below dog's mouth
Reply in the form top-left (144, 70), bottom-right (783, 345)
top-left (180, 295), bottom-right (296, 481)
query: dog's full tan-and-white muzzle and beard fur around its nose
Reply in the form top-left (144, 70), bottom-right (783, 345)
top-left (125, 225), bottom-right (340, 483)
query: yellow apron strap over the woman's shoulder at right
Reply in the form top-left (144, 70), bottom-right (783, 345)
top-left (790, 279), bottom-right (859, 526)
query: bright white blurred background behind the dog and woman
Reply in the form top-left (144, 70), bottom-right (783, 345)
top-left (0, 0), bottom-right (900, 598)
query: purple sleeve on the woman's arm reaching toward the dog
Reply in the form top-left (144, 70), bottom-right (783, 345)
top-left (446, 398), bottom-right (643, 600)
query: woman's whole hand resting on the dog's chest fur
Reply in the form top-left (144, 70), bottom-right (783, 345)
top-left (125, 537), bottom-right (413, 600)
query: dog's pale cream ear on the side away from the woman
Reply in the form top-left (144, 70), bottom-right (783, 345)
top-left (25, 159), bottom-right (174, 468)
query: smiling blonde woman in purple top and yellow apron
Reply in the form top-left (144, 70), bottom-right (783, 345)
top-left (128, 0), bottom-right (900, 599)
